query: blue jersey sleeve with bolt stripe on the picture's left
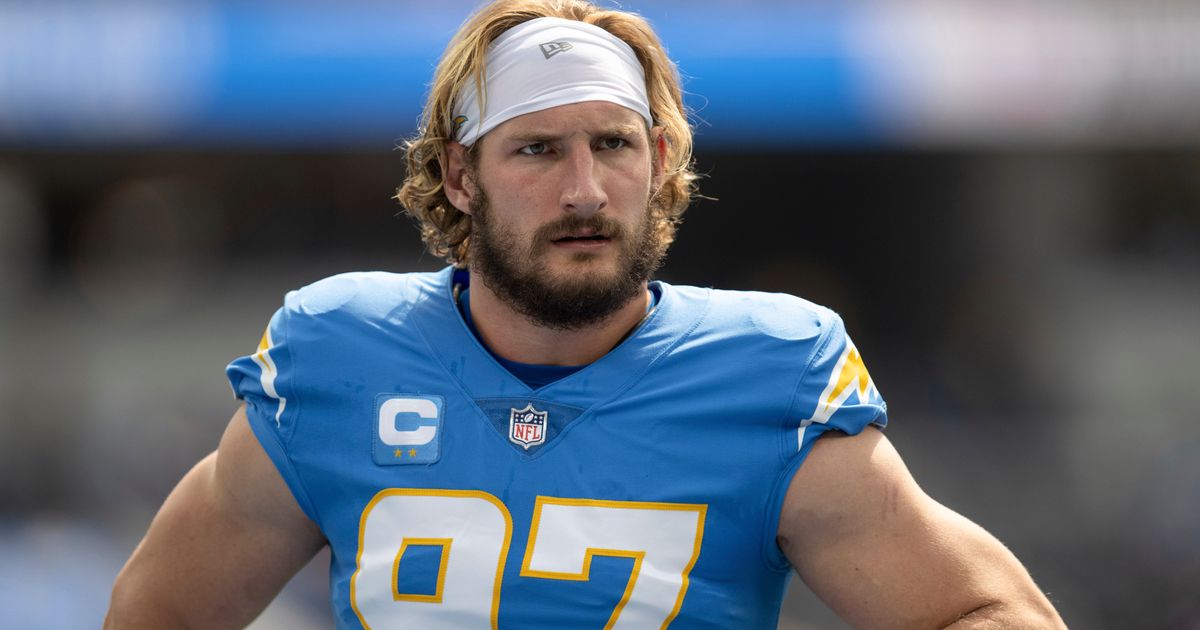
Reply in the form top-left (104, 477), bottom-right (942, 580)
top-left (219, 300), bottom-right (317, 521)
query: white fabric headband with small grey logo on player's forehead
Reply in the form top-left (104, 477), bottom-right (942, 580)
top-left (454, 18), bottom-right (654, 146)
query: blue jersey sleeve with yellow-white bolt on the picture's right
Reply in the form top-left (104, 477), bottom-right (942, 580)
top-left (792, 312), bottom-right (888, 452)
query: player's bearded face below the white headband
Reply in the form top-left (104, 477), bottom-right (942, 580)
top-left (468, 102), bottom-right (666, 330)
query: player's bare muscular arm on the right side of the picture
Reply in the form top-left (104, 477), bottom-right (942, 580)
top-left (779, 428), bottom-right (1066, 629)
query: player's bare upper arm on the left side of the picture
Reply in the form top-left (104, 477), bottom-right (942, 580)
top-left (104, 406), bottom-right (325, 630)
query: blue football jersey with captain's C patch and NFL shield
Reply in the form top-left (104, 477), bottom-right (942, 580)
top-left (227, 269), bottom-right (887, 630)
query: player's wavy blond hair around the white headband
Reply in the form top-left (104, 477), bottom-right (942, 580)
top-left (396, 0), bottom-right (697, 266)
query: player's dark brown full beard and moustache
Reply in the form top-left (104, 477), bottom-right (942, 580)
top-left (470, 188), bottom-right (667, 330)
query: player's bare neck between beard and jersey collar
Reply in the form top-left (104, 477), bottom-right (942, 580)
top-left (469, 271), bottom-right (650, 365)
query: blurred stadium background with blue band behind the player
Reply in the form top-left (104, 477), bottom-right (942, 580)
top-left (0, 0), bottom-right (1200, 630)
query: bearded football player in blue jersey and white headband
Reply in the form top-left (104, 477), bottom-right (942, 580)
top-left (106, 0), bottom-right (1062, 629)
